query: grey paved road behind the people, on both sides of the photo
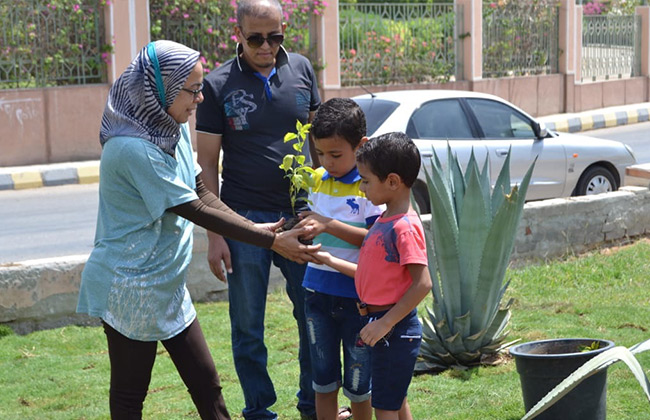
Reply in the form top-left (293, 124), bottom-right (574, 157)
top-left (0, 123), bottom-right (650, 264)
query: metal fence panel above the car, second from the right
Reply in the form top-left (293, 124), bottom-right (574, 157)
top-left (483, 0), bottom-right (559, 78)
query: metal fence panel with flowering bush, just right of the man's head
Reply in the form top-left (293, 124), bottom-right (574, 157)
top-left (339, 3), bottom-right (463, 86)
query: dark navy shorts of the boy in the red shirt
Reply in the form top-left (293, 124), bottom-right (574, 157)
top-left (367, 309), bottom-right (422, 411)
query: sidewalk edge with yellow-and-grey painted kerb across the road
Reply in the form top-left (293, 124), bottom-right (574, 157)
top-left (0, 102), bottom-right (650, 190)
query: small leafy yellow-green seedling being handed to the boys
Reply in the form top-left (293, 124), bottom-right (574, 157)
top-left (280, 121), bottom-right (314, 242)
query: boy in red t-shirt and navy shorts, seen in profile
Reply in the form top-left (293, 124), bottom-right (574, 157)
top-left (316, 133), bottom-right (431, 420)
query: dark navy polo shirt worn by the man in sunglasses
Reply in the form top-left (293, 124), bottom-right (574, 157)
top-left (196, 48), bottom-right (320, 211)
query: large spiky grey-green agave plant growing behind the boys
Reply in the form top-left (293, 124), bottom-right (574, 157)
top-left (416, 148), bottom-right (535, 372)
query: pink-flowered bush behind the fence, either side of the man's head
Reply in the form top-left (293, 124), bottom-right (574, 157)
top-left (149, 0), bottom-right (327, 72)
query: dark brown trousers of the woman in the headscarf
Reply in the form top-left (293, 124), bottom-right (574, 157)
top-left (103, 319), bottom-right (230, 420)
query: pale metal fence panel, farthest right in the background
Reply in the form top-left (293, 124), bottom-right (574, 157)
top-left (581, 15), bottom-right (641, 82)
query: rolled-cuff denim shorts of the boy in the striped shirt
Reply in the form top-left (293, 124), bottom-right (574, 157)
top-left (305, 290), bottom-right (370, 402)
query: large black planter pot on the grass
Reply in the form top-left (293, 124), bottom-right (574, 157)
top-left (510, 338), bottom-right (614, 420)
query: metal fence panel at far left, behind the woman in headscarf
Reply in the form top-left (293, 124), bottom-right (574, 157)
top-left (0, 0), bottom-right (110, 89)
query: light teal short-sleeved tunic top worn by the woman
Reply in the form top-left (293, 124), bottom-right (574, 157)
top-left (77, 126), bottom-right (198, 341)
